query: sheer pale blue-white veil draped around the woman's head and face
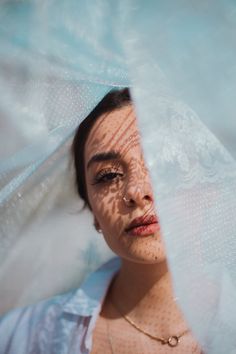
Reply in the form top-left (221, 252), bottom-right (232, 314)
top-left (0, 0), bottom-right (236, 354)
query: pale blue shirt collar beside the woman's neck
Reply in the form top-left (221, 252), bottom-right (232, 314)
top-left (63, 257), bottom-right (121, 316)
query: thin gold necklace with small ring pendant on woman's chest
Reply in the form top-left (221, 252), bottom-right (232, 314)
top-left (111, 300), bottom-right (189, 348)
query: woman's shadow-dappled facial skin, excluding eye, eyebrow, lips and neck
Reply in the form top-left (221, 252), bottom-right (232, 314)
top-left (85, 106), bottom-right (164, 263)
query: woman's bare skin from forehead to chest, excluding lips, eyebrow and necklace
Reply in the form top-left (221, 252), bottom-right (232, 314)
top-left (85, 105), bottom-right (201, 354)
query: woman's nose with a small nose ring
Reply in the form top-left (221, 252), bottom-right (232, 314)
top-left (123, 172), bottom-right (154, 208)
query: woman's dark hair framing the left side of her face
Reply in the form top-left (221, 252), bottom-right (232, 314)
top-left (71, 88), bottom-right (132, 209)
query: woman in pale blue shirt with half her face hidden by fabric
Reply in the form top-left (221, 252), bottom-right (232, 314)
top-left (0, 89), bottom-right (200, 354)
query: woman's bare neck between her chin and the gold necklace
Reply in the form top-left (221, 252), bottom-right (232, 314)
top-left (109, 260), bottom-right (183, 334)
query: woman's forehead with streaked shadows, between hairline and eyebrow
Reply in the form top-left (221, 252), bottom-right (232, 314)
top-left (85, 105), bottom-right (140, 158)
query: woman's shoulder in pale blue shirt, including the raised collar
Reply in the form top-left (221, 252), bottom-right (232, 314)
top-left (0, 258), bottom-right (120, 354)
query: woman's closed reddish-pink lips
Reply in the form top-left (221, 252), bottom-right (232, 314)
top-left (125, 215), bottom-right (160, 236)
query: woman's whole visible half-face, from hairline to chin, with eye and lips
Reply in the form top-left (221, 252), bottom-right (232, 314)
top-left (85, 105), bottom-right (165, 264)
